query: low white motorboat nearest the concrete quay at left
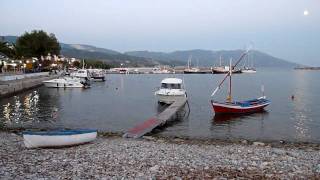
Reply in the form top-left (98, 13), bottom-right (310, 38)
top-left (43, 77), bottom-right (90, 88)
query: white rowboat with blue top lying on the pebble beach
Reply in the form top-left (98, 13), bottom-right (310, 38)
top-left (22, 129), bottom-right (97, 148)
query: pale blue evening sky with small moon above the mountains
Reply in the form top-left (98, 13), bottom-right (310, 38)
top-left (0, 0), bottom-right (320, 66)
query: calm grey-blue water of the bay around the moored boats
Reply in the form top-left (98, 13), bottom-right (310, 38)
top-left (0, 69), bottom-right (320, 143)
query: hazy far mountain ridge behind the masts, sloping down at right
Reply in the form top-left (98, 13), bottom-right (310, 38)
top-left (125, 49), bottom-right (298, 68)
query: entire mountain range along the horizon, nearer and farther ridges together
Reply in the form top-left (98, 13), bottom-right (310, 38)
top-left (0, 36), bottom-right (301, 68)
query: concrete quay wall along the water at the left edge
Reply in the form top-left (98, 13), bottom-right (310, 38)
top-left (0, 73), bottom-right (58, 97)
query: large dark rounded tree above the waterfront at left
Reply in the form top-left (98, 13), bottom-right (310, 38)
top-left (16, 30), bottom-right (61, 58)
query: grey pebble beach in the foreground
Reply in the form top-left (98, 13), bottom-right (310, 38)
top-left (0, 132), bottom-right (320, 179)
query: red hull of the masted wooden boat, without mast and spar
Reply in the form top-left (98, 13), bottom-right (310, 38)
top-left (211, 98), bottom-right (270, 114)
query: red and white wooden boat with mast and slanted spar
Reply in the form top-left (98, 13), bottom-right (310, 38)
top-left (211, 51), bottom-right (270, 114)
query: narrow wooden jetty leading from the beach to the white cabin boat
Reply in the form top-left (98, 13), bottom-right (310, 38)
top-left (123, 98), bottom-right (187, 138)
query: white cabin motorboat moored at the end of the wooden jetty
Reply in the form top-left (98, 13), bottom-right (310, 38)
top-left (155, 78), bottom-right (187, 104)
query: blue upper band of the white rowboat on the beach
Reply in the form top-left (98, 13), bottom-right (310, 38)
top-left (22, 129), bottom-right (97, 136)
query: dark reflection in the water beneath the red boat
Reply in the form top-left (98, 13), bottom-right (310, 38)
top-left (212, 110), bottom-right (269, 125)
